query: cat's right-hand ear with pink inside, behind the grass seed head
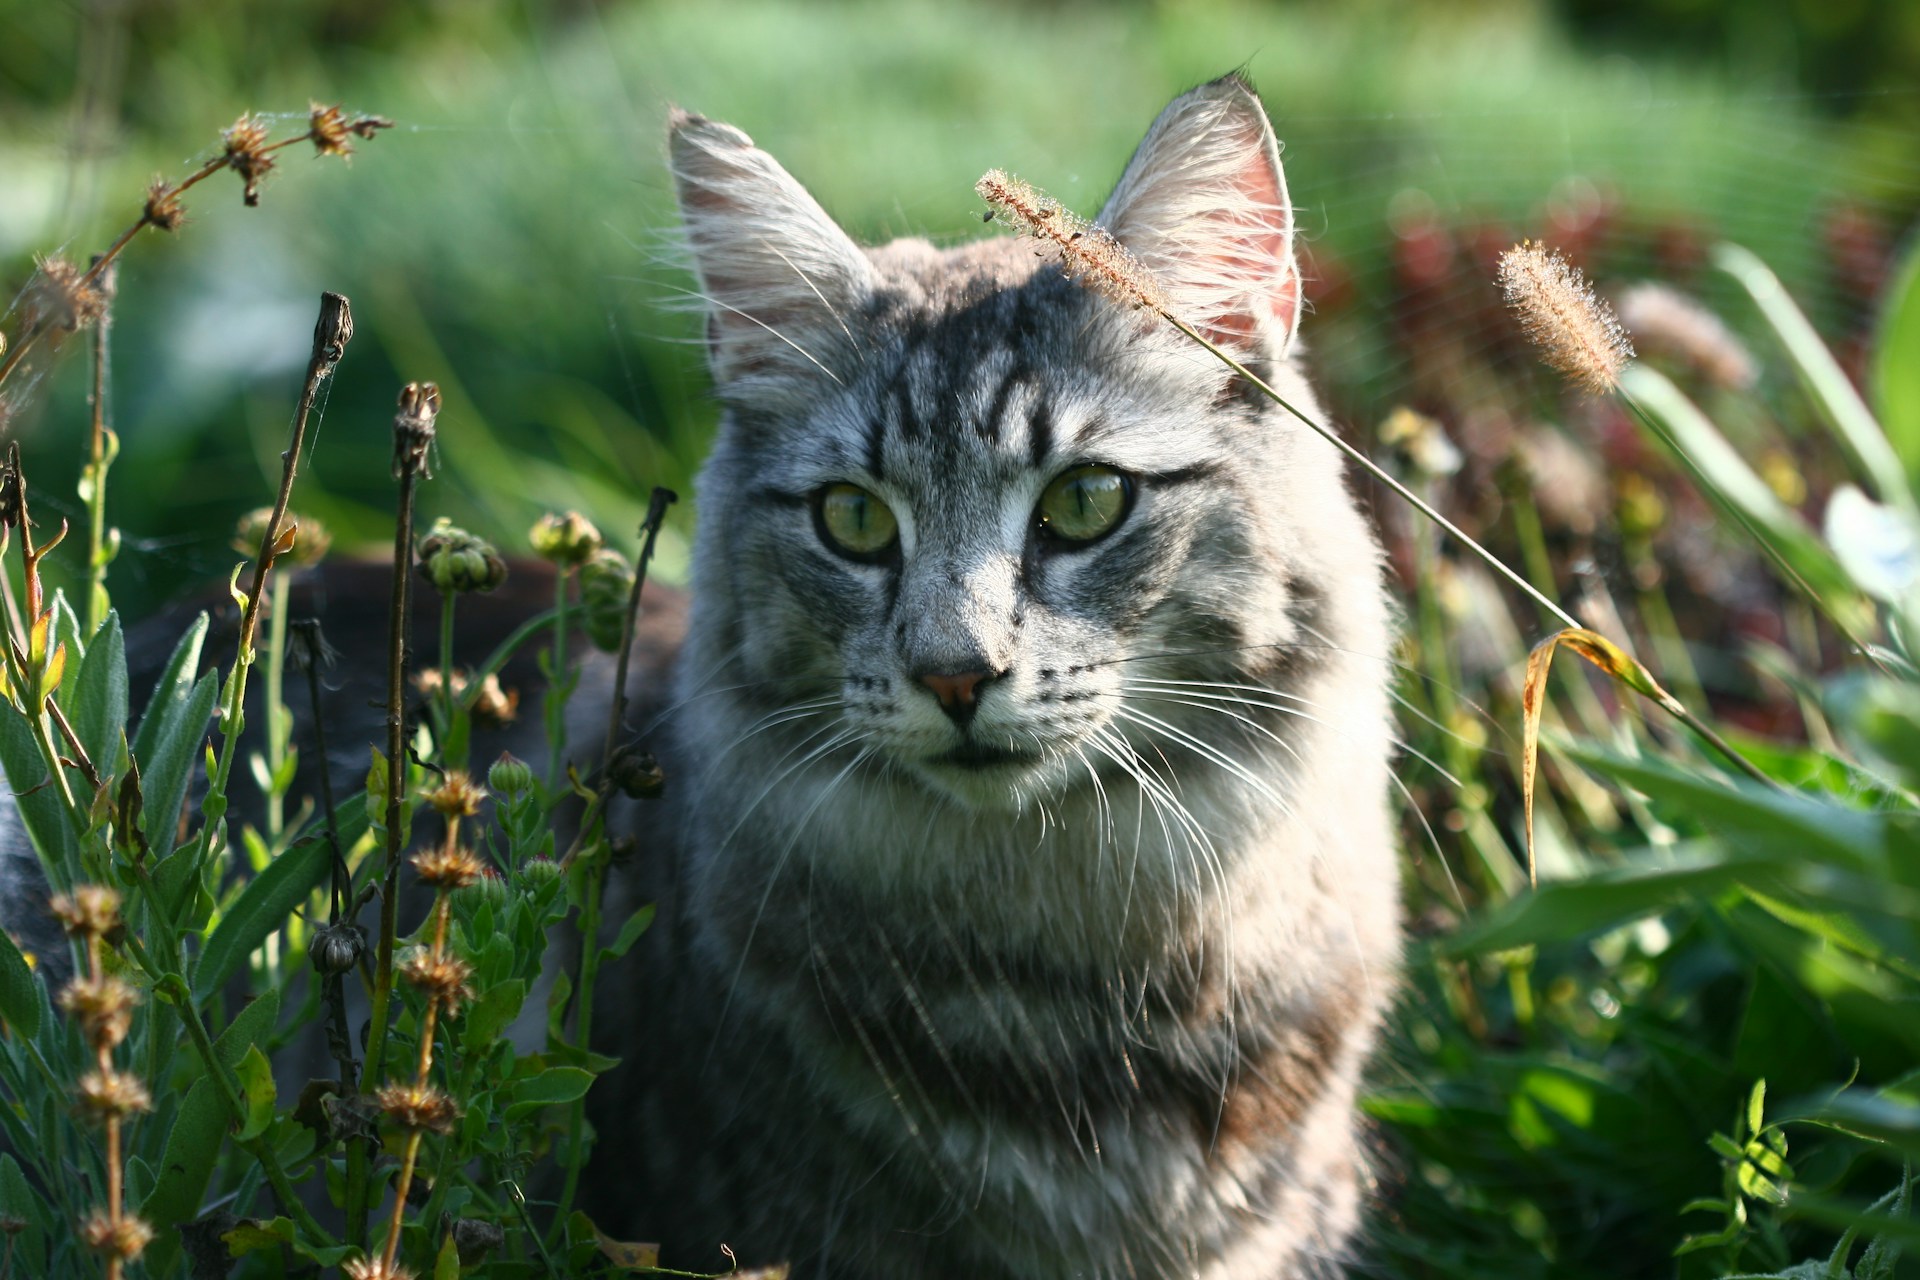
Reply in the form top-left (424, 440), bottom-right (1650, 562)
top-left (1100, 75), bottom-right (1300, 357)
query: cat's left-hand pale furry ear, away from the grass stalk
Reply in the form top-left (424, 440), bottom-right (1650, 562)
top-left (668, 109), bottom-right (874, 403)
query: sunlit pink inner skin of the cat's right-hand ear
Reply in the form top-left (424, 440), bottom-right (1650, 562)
top-left (1202, 124), bottom-right (1300, 349)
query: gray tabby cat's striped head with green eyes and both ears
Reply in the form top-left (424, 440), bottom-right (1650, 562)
top-left (674, 83), bottom-right (1346, 808)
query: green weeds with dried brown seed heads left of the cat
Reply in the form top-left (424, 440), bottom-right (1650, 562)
top-left (0, 107), bottom-right (687, 1280)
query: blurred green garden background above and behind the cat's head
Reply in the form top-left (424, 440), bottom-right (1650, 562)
top-left (0, 0), bottom-right (1920, 610)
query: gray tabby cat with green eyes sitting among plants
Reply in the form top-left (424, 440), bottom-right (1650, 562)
top-left (591, 79), bottom-right (1398, 1280)
